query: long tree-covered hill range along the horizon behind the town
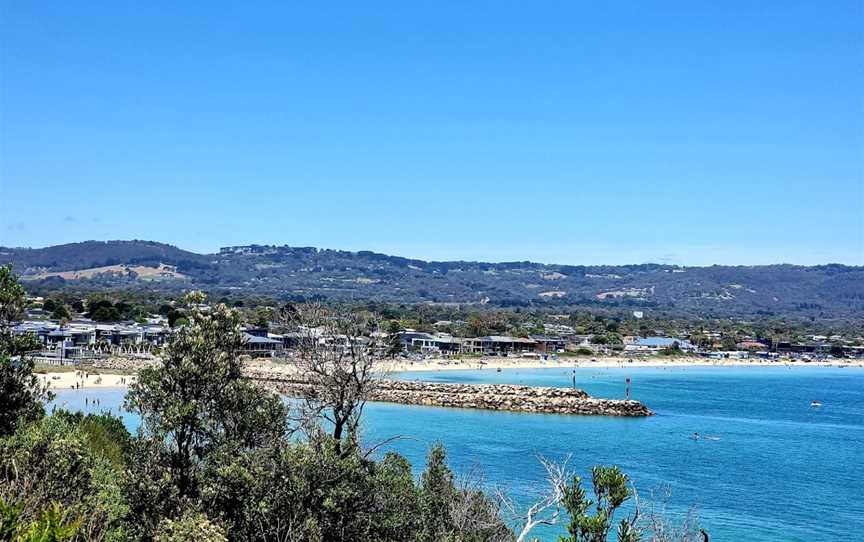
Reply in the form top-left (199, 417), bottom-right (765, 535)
top-left (0, 241), bottom-right (864, 318)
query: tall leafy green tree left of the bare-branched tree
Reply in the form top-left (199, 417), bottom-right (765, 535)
top-left (126, 294), bottom-right (287, 504)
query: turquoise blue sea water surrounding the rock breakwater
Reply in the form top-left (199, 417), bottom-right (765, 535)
top-left (50, 367), bottom-right (864, 542)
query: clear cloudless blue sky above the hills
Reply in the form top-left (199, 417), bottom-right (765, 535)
top-left (0, 0), bottom-right (864, 265)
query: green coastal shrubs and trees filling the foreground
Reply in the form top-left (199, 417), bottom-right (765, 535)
top-left (0, 267), bottom-right (704, 542)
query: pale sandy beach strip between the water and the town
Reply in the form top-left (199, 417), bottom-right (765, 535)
top-left (38, 357), bottom-right (864, 390)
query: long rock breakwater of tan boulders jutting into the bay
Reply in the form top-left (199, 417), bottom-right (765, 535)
top-left (246, 370), bottom-right (652, 417)
